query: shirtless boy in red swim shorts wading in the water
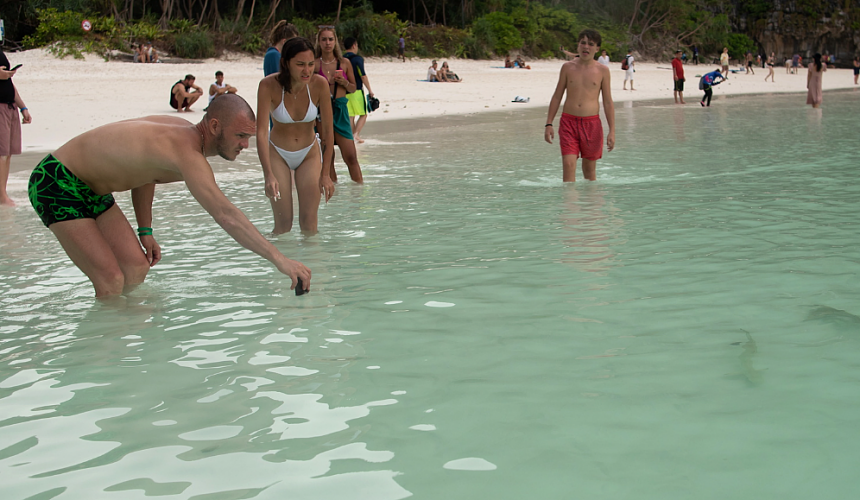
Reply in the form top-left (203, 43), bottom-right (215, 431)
top-left (544, 29), bottom-right (615, 182)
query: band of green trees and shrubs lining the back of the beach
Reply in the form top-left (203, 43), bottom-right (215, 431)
top-left (6, 0), bottom-right (840, 58)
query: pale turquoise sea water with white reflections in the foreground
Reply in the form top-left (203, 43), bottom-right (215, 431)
top-left (0, 92), bottom-right (860, 500)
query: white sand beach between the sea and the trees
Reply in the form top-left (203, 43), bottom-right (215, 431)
top-left (7, 49), bottom-right (856, 152)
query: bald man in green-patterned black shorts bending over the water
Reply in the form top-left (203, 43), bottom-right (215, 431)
top-left (28, 94), bottom-right (311, 297)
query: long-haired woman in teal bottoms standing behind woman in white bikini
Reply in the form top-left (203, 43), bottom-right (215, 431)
top-left (314, 26), bottom-right (364, 184)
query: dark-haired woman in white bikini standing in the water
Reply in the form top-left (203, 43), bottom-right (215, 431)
top-left (257, 38), bottom-right (334, 234)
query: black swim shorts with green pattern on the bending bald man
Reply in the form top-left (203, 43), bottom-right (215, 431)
top-left (27, 155), bottom-right (116, 227)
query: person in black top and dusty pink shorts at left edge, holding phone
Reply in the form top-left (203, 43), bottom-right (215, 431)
top-left (0, 49), bottom-right (33, 207)
